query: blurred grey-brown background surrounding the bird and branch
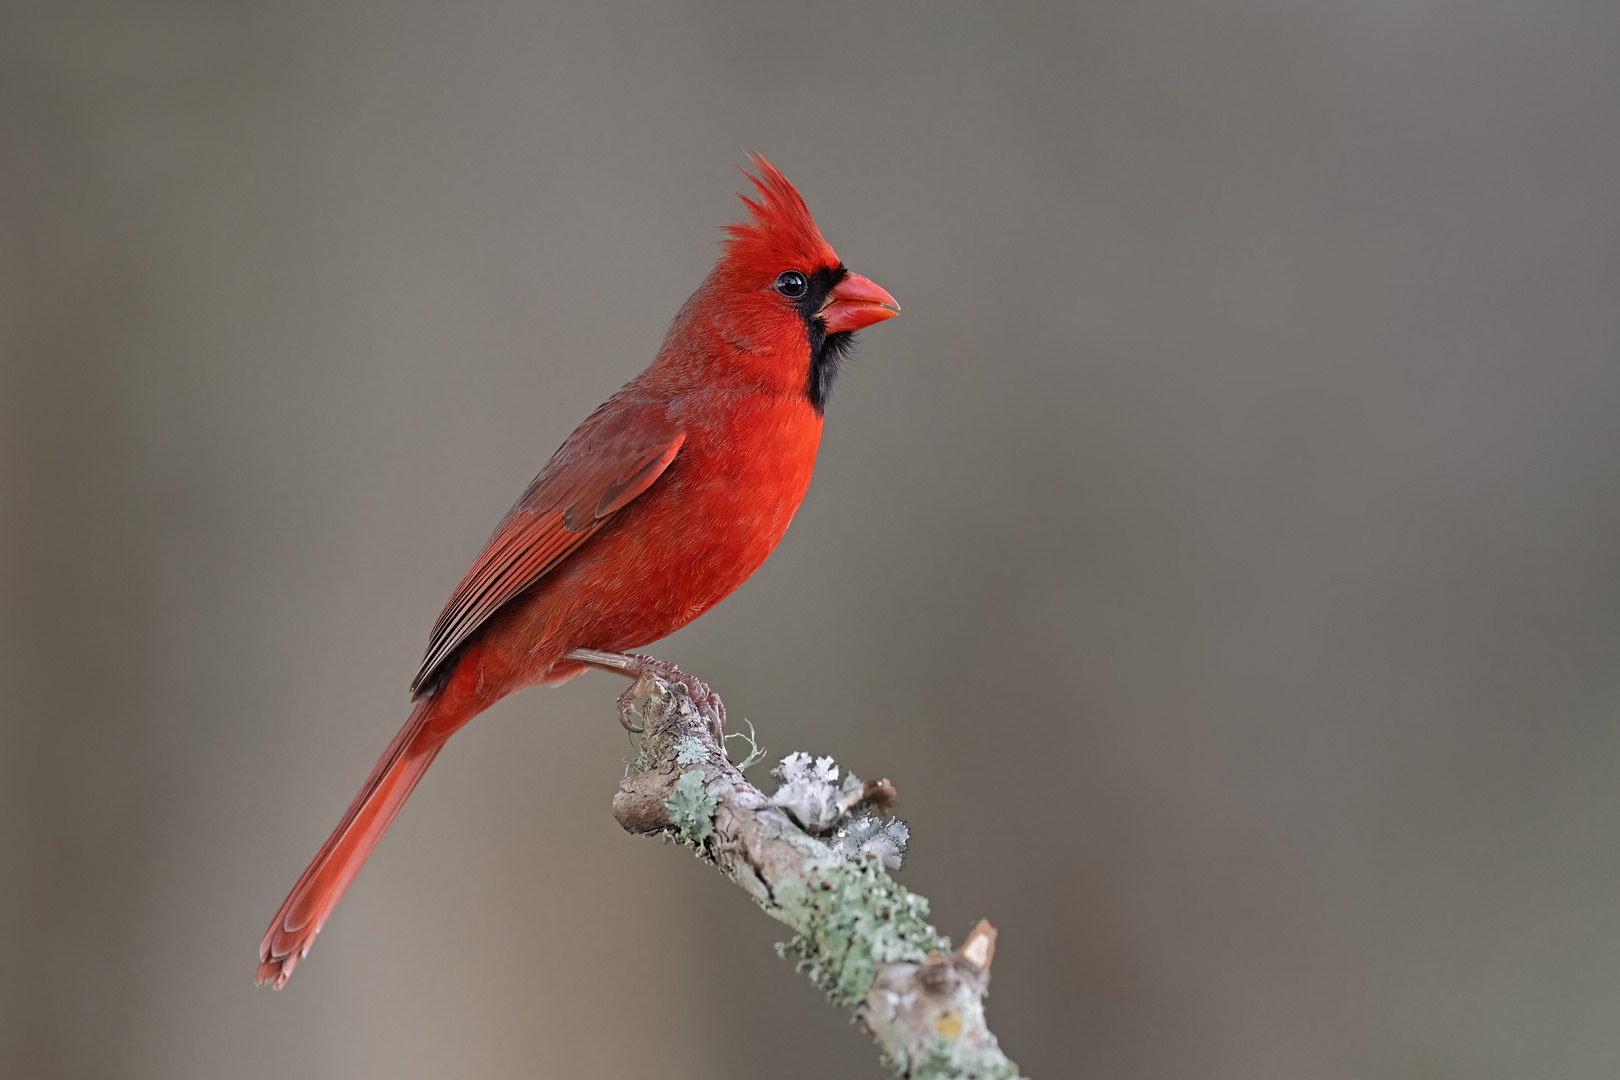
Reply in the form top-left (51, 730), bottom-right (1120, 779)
top-left (0, 0), bottom-right (1620, 1080)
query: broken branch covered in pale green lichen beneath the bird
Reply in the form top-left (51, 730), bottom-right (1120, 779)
top-left (599, 678), bottom-right (1019, 1080)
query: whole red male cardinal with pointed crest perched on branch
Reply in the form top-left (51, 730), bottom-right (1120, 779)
top-left (258, 155), bottom-right (899, 989)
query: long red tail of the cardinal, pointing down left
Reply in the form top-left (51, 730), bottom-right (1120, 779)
top-left (256, 698), bottom-right (454, 989)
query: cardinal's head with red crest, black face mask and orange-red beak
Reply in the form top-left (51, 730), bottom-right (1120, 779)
top-left (711, 154), bottom-right (901, 411)
